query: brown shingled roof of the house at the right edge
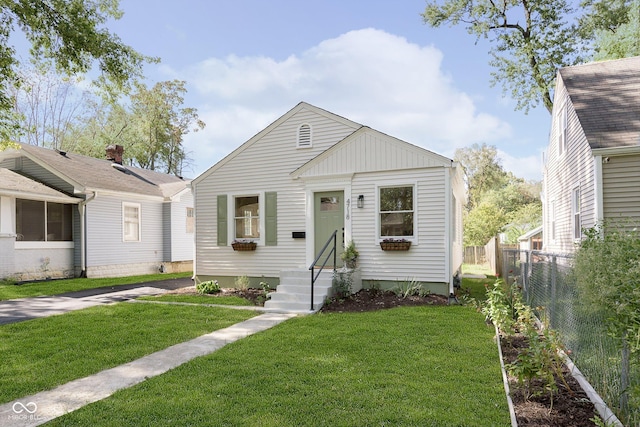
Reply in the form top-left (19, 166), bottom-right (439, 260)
top-left (559, 56), bottom-right (640, 149)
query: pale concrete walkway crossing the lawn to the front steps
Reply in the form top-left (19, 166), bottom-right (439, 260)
top-left (0, 312), bottom-right (295, 427)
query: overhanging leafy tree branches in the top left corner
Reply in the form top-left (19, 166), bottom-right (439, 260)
top-left (0, 0), bottom-right (155, 139)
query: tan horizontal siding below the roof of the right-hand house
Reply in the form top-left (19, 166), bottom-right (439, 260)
top-left (602, 154), bottom-right (640, 227)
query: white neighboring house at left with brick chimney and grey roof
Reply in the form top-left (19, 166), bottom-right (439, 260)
top-left (0, 144), bottom-right (195, 280)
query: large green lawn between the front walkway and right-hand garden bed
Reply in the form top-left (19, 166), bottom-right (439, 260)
top-left (51, 306), bottom-right (510, 426)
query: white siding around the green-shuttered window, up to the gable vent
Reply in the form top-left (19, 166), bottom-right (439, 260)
top-left (194, 104), bottom-right (357, 277)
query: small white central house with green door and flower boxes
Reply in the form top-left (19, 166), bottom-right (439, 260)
top-left (191, 102), bottom-right (466, 310)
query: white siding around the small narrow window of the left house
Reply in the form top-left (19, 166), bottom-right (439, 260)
top-left (86, 195), bottom-right (163, 275)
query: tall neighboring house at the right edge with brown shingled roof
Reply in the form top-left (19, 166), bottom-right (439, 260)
top-left (543, 57), bottom-right (640, 253)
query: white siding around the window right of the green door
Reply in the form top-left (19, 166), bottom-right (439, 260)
top-left (351, 167), bottom-right (449, 283)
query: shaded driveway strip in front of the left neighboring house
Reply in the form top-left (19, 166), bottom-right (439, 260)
top-left (0, 278), bottom-right (193, 325)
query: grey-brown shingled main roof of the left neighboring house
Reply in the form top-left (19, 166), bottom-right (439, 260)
top-left (0, 144), bottom-right (188, 198)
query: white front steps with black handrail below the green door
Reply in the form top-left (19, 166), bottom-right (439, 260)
top-left (264, 269), bottom-right (333, 313)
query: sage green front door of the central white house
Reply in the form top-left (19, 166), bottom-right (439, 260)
top-left (314, 191), bottom-right (344, 267)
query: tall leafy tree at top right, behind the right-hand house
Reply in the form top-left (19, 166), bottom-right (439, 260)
top-left (422, 0), bottom-right (584, 112)
